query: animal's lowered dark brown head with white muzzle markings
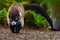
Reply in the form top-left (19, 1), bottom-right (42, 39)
top-left (9, 9), bottom-right (20, 25)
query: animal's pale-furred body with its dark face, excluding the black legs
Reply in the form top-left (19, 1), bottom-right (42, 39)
top-left (7, 3), bottom-right (25, 27)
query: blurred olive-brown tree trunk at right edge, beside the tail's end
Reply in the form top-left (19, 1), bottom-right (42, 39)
top-left (50, 5), bottom-right (60, 28)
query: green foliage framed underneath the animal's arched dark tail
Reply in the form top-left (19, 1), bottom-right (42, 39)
top-left (25, 10), bottom-right (48, 27)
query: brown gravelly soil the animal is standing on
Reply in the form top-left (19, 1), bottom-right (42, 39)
top-left (0, 24), bottom-right (60, 40)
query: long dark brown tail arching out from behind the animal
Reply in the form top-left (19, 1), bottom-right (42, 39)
top-left (23, 4), bottom-right (53, 28)
